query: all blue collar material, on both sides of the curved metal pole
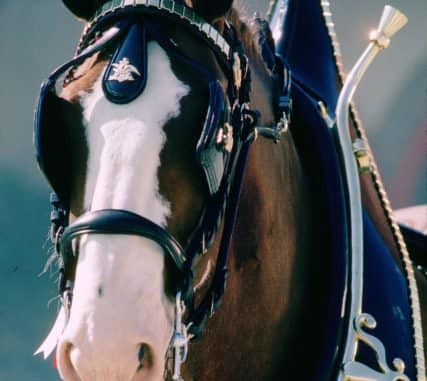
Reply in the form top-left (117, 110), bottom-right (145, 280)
top-left (270, 0), bottom-right (415, 380)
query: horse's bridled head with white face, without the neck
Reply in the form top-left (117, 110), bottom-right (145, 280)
top-left (39, 0), bottom-right (273, 381)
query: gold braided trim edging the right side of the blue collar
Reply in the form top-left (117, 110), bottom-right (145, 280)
top-left (320, 0), bottom-right (426, 381)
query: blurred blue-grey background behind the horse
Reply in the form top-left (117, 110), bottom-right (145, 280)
top-left (0, 0), bottom-right (427, 381)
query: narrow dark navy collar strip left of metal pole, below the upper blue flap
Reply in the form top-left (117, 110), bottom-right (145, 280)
top-left (291, 81), bottom-right (349, 380)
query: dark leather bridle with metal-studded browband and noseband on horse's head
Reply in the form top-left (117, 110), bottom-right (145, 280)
top-left (35, 0), bottom-right (290, 380)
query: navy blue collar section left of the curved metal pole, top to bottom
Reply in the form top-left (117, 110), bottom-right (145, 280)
top-left (276, 0), bottom-right (349, 380)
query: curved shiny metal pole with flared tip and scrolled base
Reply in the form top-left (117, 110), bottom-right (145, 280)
top-left (336, 5), bottom-right (407, 381)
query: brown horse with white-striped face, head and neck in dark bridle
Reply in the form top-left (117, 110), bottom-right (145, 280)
top-left (36, 0), bottom-right (422, 381)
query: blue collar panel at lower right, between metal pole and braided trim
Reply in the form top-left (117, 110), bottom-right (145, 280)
top-left (358, 209), bottom-right (415, 380)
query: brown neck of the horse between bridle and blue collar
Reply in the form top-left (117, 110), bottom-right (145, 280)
top-left (182, 8), bottom-right (321, 381)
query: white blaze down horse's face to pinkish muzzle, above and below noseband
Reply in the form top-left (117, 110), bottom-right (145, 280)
top-left (59, 42), bottom-right (189, 381)
